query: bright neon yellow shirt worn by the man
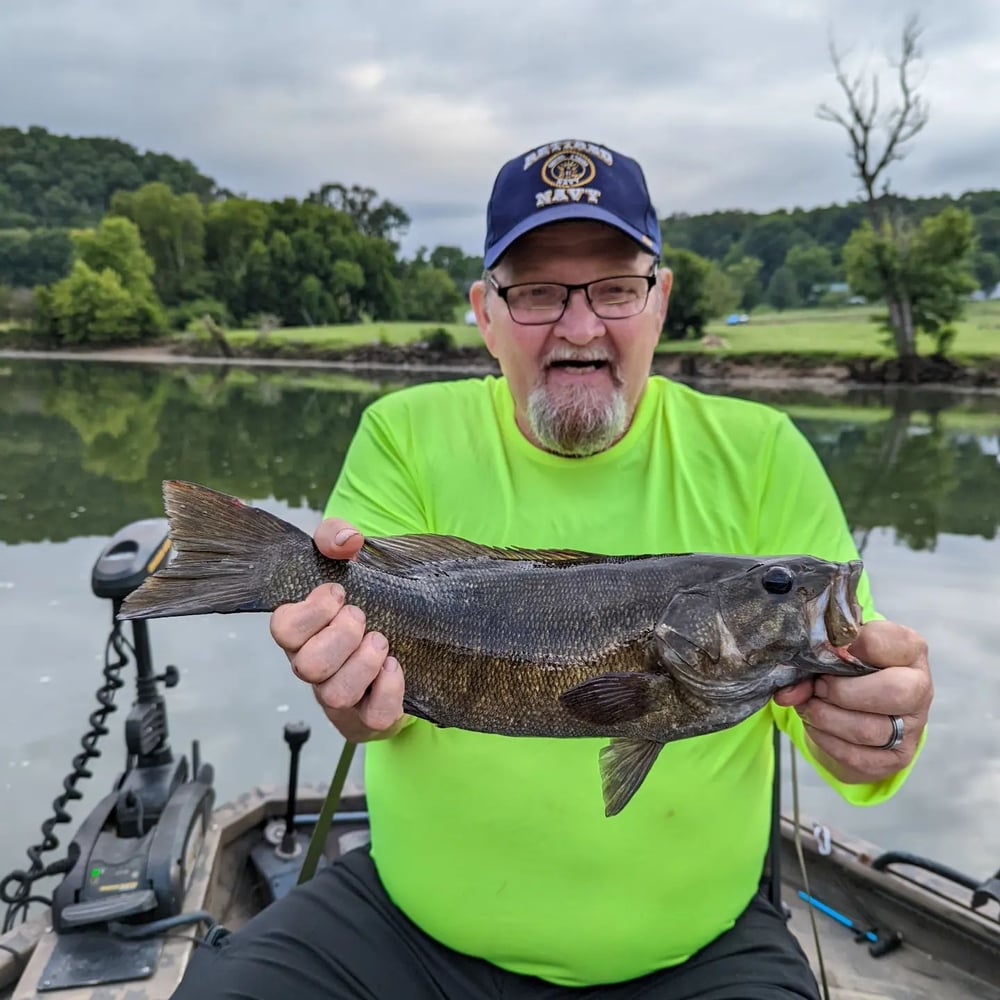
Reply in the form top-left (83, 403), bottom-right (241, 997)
top-left (326, 378), bottom-right (920, 986)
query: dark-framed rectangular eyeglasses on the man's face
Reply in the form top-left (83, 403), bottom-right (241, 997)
top-left (488, 269), bottom-right (656, 326)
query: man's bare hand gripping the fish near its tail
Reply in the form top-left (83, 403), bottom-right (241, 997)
top-left (271, 518), bottom-right (406, 743)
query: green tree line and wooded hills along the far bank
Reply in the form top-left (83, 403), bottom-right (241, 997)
top-left (0, 107), bottom-right (1000, 349)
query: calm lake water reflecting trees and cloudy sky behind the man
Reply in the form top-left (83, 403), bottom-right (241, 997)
top-left (0, 359), bottom-right (1000, 908)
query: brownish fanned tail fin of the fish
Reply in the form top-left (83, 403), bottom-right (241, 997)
top-left (118, 480), bottom-right (315, 619)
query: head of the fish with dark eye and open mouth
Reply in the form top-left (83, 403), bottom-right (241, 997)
top-left (654, 556), bottom-right (875, 714)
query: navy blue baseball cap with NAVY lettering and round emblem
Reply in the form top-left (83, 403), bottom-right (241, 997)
top-left (483, 139), bottom-right (660, 267)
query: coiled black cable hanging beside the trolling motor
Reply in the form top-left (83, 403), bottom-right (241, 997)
top-left (0, 616), bottom-right (135, 933)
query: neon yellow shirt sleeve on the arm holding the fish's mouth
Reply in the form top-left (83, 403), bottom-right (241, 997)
top-left (757, 416), bottom-right (927, 805)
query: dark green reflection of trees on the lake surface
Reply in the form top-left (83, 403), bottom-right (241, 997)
top-left (0, 362), bottom-right (1000, 550)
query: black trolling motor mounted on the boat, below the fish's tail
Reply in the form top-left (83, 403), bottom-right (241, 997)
top-left (15, 519), bottom-right (215, 989)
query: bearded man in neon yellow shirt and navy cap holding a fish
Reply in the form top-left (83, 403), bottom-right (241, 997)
top-left (178, 141), bottom-right (931, 1000)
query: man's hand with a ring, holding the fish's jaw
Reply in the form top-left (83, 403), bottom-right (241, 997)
top-left (774, 621), bottom-right (934, 784)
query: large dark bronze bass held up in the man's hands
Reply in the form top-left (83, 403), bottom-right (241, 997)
top-left (118, 480), bottom-right (876, 817)
